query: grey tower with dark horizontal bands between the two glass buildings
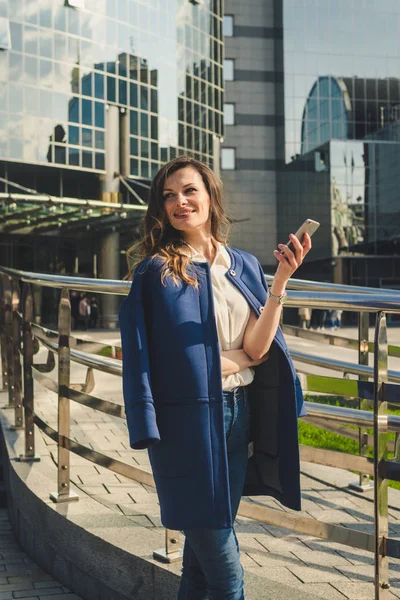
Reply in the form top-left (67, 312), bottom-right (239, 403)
top-left (221, 0), bottom-right (284, 268)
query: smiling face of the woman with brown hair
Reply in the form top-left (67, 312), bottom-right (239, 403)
top-left (163, 167), bottom-right (211, 237)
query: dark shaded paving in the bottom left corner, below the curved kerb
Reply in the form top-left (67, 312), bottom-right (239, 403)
top-left (0, 508), bottom-right (82, 600)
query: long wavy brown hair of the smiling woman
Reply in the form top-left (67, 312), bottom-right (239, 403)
top-left (126, 156), bottom-right (230, 288)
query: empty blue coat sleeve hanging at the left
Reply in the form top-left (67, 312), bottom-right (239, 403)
top-left (119, 270), bottom-right (160, 449)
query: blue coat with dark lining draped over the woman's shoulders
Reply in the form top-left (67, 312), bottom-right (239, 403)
top-left (120, 248), bottom-right (305, 530)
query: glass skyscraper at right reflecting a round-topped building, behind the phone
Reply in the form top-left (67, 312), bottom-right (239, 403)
top-left (278, 0), bottom-right (400, 287)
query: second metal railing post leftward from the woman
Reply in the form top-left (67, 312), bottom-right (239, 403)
top-left (19, 283), bottom-right (40, 462)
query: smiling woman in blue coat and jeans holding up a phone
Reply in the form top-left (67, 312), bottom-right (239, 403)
top-left (120, 157), bottom-right (311, 600)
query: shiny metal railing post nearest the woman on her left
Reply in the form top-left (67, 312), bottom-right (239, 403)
top-left (50, 289), bottom-right (79, 502)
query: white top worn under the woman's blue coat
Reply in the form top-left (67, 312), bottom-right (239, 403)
top-left (188, 243), bottom-right (254, 392)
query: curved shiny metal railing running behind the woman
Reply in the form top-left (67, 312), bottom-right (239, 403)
top-left (0, 267), bottom-right (400, 600)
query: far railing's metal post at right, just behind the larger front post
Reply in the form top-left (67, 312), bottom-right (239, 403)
top-left (349, 312), bottom-right (374, 492)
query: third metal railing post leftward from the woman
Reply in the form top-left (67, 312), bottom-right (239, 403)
top-left (10, 279), bottom-right (24, 430)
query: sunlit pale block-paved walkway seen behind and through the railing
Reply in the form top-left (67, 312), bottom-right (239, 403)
top-left (27, 332), bottom-right (400, 600)
